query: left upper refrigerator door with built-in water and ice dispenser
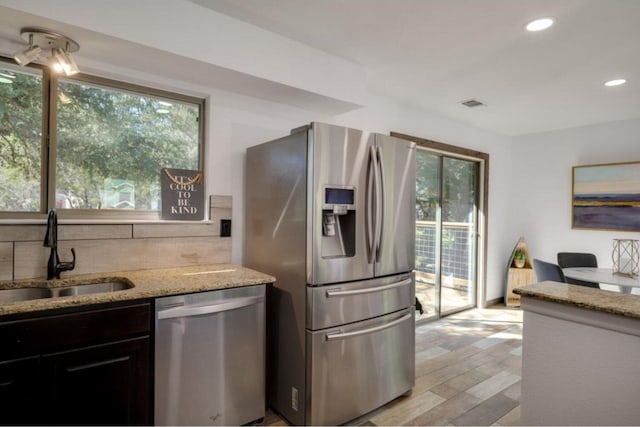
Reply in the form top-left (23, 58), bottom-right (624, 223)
top-left (307, 122), bottom-right (375, 285)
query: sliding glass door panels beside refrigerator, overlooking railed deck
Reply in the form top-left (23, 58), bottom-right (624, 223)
top-left (416, 147), bottom-right (480, 319)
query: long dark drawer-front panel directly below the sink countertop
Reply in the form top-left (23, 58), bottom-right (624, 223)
top-left (0, 303), bottom-right (151, 359)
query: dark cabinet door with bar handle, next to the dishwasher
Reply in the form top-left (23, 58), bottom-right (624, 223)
top-left (42, 337), bottom-right (152, 425)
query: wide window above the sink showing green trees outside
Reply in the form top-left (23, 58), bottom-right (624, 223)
top-left (0, 57), bottom-right (204, 219)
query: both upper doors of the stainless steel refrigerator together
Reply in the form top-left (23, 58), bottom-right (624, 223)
top-left (307, 122), bottom-right (416, 285)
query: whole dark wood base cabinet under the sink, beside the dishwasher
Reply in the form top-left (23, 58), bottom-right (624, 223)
top-left (0, 303), bottom-right (153, 425)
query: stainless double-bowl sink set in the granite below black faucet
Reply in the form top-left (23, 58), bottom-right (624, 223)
top-left (0, 278), bottom-right (134, 304)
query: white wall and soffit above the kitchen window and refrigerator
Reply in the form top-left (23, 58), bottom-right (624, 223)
top-left (0, 0), bottom-right (520, 300)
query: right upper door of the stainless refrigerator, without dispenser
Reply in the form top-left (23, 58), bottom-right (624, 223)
top-left (375, 134), bottom-right (416, 276)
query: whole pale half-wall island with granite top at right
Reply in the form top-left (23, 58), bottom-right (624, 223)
top-left (514, 281), bottom-right (640, 425)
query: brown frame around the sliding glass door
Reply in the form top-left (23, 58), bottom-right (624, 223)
top-left (391, 132), bottom-right (489, 323)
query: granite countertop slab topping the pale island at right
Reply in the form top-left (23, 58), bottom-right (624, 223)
top-left (513, 281), bottom-right (640, 318)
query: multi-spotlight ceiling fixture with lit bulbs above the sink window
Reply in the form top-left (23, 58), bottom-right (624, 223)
top-left (13, 28), bottom-right (80, 76)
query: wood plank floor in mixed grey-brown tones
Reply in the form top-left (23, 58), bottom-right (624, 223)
top-left (264, 306), bottom-right (522, 426)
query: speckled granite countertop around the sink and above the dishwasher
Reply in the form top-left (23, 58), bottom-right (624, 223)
top-left (0, 264), bottom-right (275, 316)
